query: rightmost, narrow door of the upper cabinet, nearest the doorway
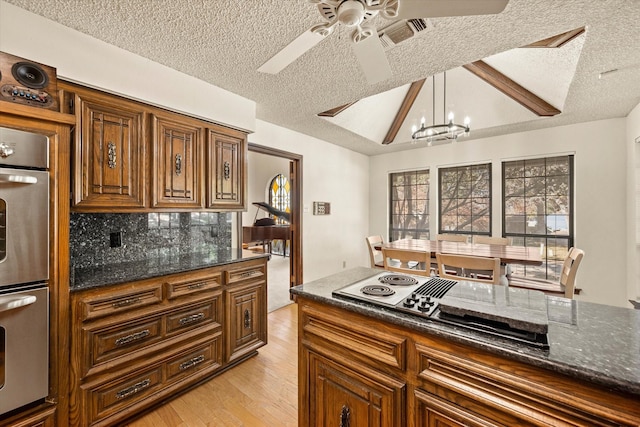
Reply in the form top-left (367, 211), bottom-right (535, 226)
top-left (207, 130), bottom-right (247, 209)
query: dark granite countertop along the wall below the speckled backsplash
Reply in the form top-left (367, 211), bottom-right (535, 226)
top-left (70, 248), bottom-right (268, 292)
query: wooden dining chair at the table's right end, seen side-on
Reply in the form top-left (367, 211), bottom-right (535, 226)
top-left (509, 247), bottom-right (584, 299)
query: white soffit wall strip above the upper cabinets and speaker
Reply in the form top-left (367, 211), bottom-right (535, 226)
top-left (0, 1), bottom-right (256, 131)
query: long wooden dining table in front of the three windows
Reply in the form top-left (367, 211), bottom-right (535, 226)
top-left (375, 239), bottom-right (542, 265)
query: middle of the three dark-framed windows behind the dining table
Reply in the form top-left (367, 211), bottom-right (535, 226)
top-left (439, 163), bottom-right (491, 235)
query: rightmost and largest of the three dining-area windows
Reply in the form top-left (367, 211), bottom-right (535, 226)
top-left (502, 156), bottom-right (573, 280)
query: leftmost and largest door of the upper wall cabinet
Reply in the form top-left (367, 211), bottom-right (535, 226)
top-left (73, 95), bottom-right (145, 210)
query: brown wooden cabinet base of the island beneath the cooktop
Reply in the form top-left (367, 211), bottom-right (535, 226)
top-left (297, 295), bottom-right (640, 427)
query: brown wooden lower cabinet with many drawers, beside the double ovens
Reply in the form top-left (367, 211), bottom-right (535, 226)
top-left (70, 258), bottom-right (267, 426)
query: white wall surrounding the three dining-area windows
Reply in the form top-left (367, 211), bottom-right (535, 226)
top-left (369, 119), bottom-right (630, 307)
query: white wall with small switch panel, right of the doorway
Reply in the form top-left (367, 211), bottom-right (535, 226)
top-left (249, 120), bottom-right (369, 282)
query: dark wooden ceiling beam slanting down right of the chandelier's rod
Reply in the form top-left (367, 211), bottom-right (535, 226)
top-left (463, 61), bottom-right (561, 117)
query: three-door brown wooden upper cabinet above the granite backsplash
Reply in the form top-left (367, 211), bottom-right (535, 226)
top-left (58, 81), bottom-right (247, 212)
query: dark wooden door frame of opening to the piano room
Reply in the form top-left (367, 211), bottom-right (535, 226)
top-left (248, 142), bottom-right (303, 287)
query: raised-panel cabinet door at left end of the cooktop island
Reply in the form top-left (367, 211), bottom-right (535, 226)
top-left (308, 352), bottom-right (406, 427)
